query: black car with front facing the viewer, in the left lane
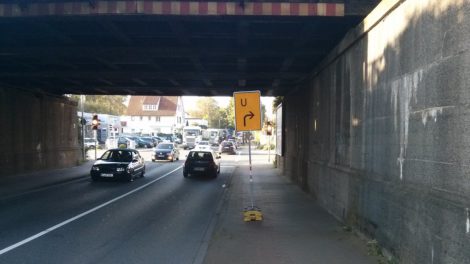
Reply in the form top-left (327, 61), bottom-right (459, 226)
top-left (90, 149), bottom-right (145, 181)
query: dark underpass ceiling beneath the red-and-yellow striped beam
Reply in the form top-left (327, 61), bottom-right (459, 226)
top-left (0, 3), bottom-right (376, 96)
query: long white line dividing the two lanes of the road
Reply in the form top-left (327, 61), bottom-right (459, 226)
top-left (0, 166), bottom-right (183, 256)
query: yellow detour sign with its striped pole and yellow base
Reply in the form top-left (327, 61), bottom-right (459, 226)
top-left (233, 91), bottom-right (263, 222)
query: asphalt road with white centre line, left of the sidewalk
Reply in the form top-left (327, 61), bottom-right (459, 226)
top-left (0, 152), bottom-right (236, 263)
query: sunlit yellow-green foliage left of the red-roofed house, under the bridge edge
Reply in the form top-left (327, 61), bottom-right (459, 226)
top-left (70, 95), bottom-right (126, 115)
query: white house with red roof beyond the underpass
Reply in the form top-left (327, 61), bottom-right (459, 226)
top-left (121, 96), bottom-right (185, 136)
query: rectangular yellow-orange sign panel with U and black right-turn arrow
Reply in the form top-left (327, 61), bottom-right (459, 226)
top-left (233, 91), bottom-right (261, 131)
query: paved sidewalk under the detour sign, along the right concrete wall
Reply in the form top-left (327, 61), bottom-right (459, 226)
top-left (204, 163), bottom-right (377, 264)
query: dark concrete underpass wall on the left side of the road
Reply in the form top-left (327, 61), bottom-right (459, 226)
top-left (0, 88), bottom-right (81, 177)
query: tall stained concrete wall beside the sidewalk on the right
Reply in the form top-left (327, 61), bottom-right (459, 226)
top-left (280, 0), bottom-right (470, 263)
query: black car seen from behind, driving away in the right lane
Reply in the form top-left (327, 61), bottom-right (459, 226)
top-left (183, 150), bottom-right (220, 178)
